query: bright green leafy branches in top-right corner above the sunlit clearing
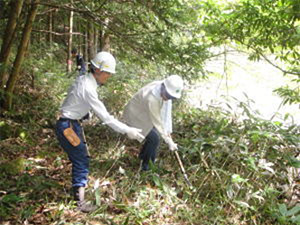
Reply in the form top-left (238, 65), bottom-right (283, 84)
top-left (199, 0), bottom-right (300, 104)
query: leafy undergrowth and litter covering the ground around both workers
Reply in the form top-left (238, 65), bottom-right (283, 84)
top-left (0, 53), bottom-right (300, 225)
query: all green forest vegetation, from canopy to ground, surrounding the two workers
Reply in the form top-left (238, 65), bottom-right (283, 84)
top-left (0, 0), bottom-right (300, 225)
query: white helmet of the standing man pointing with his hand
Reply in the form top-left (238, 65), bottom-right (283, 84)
top-left (91, 52), bottom-right (116, 73)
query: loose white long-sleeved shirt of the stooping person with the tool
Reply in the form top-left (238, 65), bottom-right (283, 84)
top-left (123, 81), bottom-right (172, 140)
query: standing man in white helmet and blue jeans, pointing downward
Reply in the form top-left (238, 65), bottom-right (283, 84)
top-left (56, 52), bottom-right (144, 212)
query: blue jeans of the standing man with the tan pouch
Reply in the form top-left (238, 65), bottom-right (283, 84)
top-left (56, 118), bottom-right (90, 187)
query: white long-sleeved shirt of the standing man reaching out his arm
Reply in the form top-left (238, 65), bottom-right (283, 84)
top-left (61, 73), bottom-right (129, 134)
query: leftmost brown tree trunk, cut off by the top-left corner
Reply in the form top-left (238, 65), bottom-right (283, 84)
top-left (0, 0), bottom-right (23, 88)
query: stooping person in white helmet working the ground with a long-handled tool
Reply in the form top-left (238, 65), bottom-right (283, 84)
top-left (123, 75), bottom-right (183, 171)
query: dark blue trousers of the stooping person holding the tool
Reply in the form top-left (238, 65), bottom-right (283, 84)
top-left (139, 128), bottom-right (160, 170)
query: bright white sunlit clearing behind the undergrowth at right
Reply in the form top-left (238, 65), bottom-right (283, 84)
top-left (187, 49), bottom-right (300, 124)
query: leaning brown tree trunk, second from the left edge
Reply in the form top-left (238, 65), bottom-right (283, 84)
top-left (3, 0), bottom-right (39, 110)
